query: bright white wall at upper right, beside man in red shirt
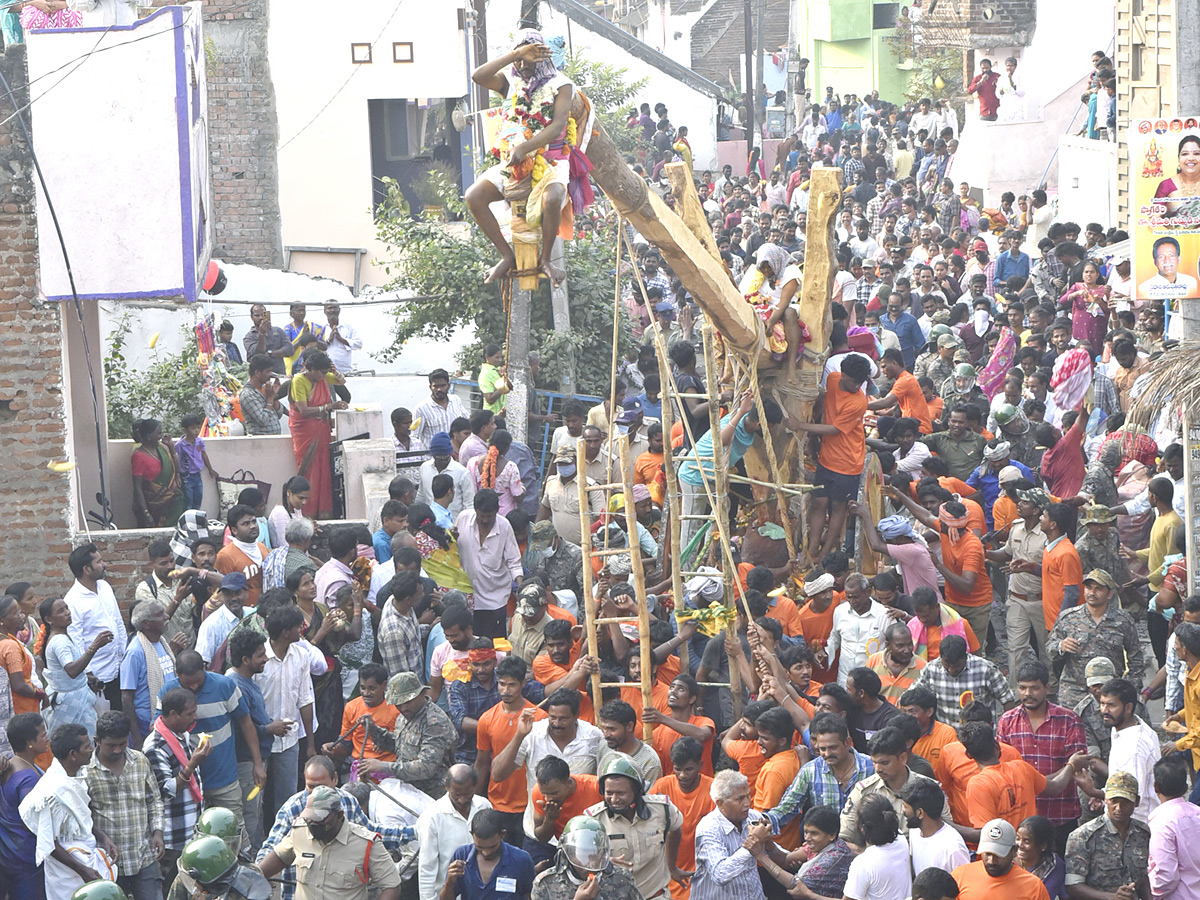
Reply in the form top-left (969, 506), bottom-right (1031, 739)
top-left (950, 0), bottom-right (1116, 206)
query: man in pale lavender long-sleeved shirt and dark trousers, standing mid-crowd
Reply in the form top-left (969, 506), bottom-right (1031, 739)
top-left (455, 487), bottom-right (524, 638)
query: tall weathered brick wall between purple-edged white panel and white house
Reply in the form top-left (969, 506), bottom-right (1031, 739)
top-left (154, 0), bottom-right (283, 269)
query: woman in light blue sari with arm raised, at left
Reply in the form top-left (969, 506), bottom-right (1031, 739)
top-left (38, 598), bottom-right (113, 734)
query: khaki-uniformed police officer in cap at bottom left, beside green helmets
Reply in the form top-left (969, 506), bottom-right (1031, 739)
top-left (259, 786), bottom-right (400, 900)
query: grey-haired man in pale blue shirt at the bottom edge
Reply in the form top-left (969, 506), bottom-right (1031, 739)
top-left (691, 769), bottom-right (780, 900)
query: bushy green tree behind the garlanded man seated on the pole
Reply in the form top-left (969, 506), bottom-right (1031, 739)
top-left (376, 180), bottom-right (630, 395)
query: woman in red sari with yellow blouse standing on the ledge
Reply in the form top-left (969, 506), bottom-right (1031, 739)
top-left (288, 350), bottom-right (347, 517)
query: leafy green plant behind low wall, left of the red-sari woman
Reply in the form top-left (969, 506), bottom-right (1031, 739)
top-left (104, 312), bottom-right (202, 438)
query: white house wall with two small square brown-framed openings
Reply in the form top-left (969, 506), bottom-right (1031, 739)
top-left (268, 0), bottom-right (469, 284)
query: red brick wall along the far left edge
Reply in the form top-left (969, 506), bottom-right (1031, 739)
top-left (0, 46), bottom-right (71, 600)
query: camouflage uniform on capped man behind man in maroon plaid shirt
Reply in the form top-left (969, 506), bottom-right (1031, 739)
top-left (1046, 602), bottom-right (1146, 709)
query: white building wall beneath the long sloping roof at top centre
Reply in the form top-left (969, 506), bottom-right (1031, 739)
top-left (487, 0), bottom-right (716, 169)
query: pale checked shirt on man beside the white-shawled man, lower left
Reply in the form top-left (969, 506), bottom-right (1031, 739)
top-left (84, 749), bottom-right (163, 875)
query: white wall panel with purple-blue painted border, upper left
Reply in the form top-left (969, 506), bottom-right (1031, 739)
top-left (28, 2), bottom-right (212, 307)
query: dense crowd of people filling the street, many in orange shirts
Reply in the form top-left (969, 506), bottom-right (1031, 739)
top-left (0, 24), bottom-right (1200, 900)
